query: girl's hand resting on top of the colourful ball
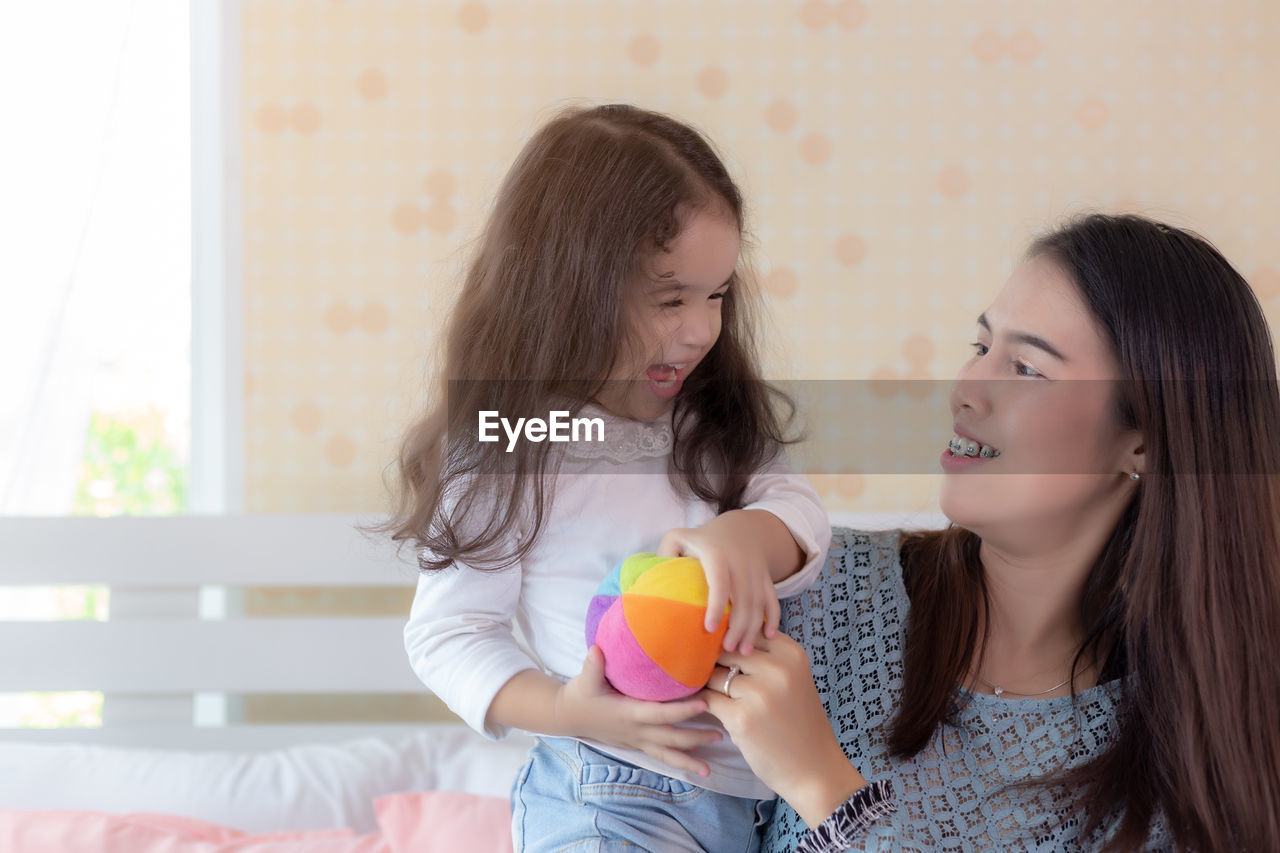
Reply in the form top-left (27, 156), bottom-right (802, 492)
top-left (658, 510), bottom-right (804, 654)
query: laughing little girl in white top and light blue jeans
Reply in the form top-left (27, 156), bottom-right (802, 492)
top-left (393, 105), bottom-right (831, 850)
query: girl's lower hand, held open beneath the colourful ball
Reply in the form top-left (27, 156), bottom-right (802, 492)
top-left (554, 646), bottom-right (722, 776)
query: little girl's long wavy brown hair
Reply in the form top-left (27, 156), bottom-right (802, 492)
top-left (380, 105), bottom-right (790, 570)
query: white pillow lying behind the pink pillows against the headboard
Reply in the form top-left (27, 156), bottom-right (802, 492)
top-left (0, 725), bottom-right (532, 833)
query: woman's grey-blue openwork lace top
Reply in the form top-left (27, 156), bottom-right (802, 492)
top-left (764, 528), bottom-right (1172, 852)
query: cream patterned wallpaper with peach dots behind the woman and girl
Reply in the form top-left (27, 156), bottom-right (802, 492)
top-left (239, 0), bottom-right (1280, 512)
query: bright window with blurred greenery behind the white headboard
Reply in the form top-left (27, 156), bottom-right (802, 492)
top-left (0, 0), bottom-right (221, 725)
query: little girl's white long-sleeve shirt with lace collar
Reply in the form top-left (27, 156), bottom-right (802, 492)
top-left (404, 407), bottom-right (831, 798)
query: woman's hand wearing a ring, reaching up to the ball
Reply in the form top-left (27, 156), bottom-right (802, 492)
top-left (698, 634), bottom-right (867, 826)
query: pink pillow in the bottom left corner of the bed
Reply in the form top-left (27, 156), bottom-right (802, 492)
top-left (0, 811), bottom-right (389, 853)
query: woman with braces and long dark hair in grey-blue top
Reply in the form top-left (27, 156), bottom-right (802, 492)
top-left (704, 215), bottom-right (1280, 850)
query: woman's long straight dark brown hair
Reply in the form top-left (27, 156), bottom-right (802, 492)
top-left (890, 214), bottom-right (1280, 850)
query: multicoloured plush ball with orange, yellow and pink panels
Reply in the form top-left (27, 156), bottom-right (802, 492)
top-left (586, 553), bottom-right (728, 702)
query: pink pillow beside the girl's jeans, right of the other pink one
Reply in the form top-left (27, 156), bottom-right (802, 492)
top-left (374, 790), bottom-right (512, 853)
